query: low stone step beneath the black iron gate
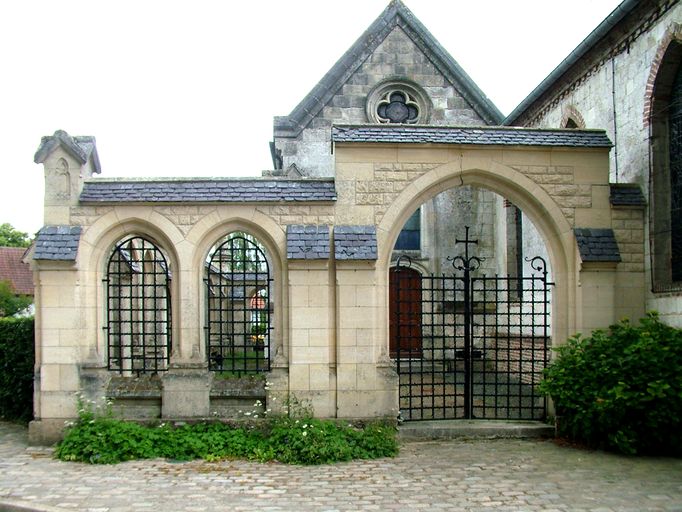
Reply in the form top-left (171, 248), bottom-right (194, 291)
top-left (398, 420), bottom-right (554, 440)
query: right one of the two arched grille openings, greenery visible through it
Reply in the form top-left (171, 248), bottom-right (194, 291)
top-left (205, 232), bottom-right (273, 376)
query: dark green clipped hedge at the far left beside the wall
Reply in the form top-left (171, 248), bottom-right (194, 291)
top-left (0, 318), bottom-right (35, 421)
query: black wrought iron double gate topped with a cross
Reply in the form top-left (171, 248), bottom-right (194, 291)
top-left (389, 228), bottom-right (552, 420)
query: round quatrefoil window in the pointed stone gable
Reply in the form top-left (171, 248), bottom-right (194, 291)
top-left (366, 78), bottom-right (431, 124)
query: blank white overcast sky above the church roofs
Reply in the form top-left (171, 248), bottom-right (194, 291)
top-left (0, 0), bottom-right (619, 233)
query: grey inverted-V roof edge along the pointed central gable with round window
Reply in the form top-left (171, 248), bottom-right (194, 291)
top-left (275, 0), bottom-right (504, 137)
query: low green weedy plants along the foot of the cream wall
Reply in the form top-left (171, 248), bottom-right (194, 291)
top-left (55, 402), bottom-right (398, 464)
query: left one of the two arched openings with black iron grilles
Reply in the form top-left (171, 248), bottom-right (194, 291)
top-left (104, 236), bottom-right (171, 375)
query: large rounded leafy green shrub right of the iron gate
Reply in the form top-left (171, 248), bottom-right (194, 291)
top-left (540, 313), bottom-right (682, 454)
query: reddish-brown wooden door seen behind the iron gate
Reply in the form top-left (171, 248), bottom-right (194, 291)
top-left (388, 267), bottom-right (422, 358)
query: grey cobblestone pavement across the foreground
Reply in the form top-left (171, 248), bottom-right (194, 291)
top-left (0, 423), bottom-right (682, 512)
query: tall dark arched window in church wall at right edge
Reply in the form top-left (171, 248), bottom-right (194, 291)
top-left (651, 41), bottom-right (682, 292)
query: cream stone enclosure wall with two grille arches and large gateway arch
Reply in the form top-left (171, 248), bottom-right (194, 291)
top-left (31, 133), bottom-right (643, 441)
